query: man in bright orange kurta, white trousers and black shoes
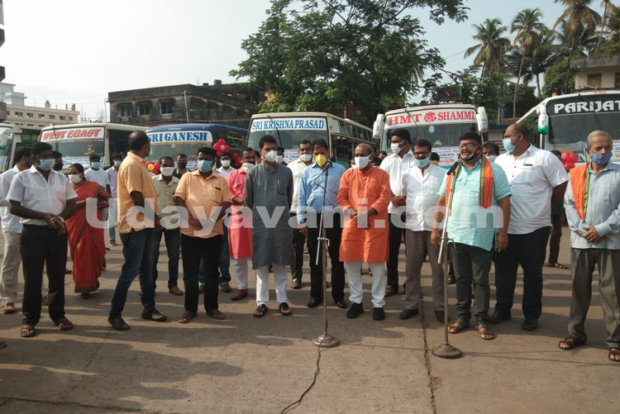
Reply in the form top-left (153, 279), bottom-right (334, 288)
top-left (338, 144), bottom-right (391, 321)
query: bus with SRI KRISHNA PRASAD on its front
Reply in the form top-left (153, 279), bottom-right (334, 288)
top-left (247, 112), bottom-right (372, 168)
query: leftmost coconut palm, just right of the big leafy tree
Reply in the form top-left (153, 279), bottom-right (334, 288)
top-left (465, 19), bottom-right (510, 79)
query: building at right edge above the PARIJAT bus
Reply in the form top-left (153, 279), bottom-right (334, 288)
top-left (570, 55), bottom-right (620, 92)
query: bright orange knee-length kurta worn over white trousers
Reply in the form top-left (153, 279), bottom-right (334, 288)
top-left (338, 168), bottom-right (392, 263)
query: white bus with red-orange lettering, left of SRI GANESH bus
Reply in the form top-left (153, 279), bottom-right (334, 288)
top-left (39, 122), bottom-right (146, 172)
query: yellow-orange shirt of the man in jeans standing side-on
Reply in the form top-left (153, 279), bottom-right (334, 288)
top-left (117, 152), bottom-right (157, 234)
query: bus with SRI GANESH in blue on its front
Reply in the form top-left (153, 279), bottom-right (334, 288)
top-left (146, 124), bottom-right (248, 170)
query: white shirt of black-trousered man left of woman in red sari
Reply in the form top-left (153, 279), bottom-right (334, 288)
top-left (8, 165), bottom-right (77, 226)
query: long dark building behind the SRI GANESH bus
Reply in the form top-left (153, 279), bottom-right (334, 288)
top-left (108, 80), bottom-right (265, 128)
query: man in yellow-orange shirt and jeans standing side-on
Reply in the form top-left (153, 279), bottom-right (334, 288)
top-left (108, 131), bottom-right (167, 331)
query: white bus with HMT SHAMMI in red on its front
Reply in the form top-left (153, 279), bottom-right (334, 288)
top-left (373, 104), bottom-right (489, 167)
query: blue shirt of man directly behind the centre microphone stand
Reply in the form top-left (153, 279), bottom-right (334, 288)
top-left (297, 163), bottom-right (346, 223)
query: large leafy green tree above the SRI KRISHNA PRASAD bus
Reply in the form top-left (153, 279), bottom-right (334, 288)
top-left (230, 0), bottom-right (466, 124)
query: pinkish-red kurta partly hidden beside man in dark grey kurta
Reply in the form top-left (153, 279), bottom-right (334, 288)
top-left (226, 169), bottom-right (252, 259)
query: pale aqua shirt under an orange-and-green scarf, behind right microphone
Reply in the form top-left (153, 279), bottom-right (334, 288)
top-left (439, 160), bottom-right (510, 250)
